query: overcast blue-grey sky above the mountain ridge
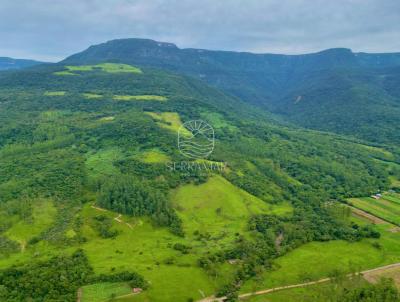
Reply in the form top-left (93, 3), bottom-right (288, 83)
top-left (0, 0), bottom-right (400, 62)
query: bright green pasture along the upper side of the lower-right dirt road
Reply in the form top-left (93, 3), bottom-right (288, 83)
top-left (241, 224), bottom-right (400, 301)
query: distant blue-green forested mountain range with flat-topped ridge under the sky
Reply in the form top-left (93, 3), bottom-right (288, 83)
top-left (61, 39), bottom-right (400, 144)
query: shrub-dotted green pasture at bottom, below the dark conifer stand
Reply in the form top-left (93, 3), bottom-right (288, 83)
top-left (77, 205), bottom-right (221, 302)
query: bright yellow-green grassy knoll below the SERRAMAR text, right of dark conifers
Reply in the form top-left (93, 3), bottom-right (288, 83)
top-left (173, 176), bottom-right (291, 245)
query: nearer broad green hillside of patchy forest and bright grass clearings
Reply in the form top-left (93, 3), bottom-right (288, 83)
top-left (0, 56), bottom-right (400, 301)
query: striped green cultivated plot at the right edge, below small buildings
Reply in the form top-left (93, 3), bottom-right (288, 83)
top-left (349, 193), bottom-right (400, 225)
